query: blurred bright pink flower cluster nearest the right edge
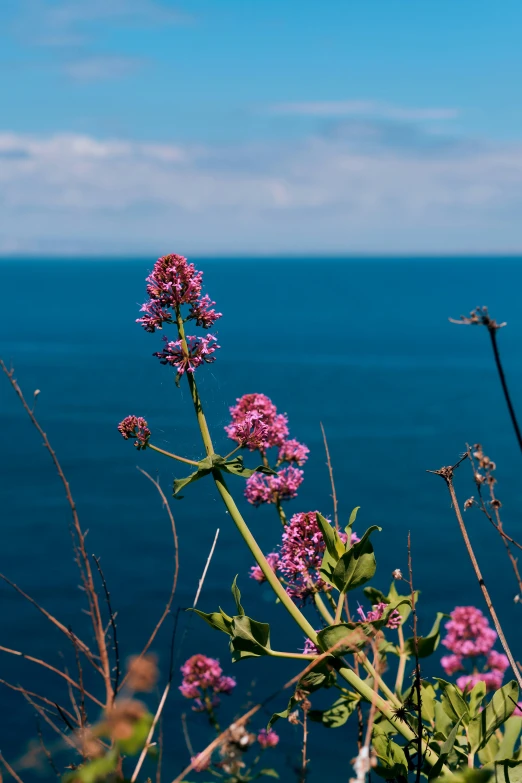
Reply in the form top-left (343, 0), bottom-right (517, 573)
top-left (441, 606), bottom-right (509, 692)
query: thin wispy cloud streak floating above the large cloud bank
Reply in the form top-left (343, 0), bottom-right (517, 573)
top-left (268, 101), bottom-right (458, 120)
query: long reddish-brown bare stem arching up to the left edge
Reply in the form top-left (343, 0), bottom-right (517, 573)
top-left (0, 359), bottom-right (112, 704)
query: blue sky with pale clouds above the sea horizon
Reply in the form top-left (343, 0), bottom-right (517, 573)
top-left (0, 0), bottom-right (522, 254)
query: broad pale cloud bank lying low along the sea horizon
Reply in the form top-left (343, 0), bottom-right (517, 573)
top-left (0, 123), bottom-right (522, 254)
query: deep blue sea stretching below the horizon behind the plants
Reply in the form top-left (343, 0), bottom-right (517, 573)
top-left (0, 258), bottom-right (522, 783)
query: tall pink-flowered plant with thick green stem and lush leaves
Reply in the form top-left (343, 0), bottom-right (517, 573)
top-left (115, 256), bottom-right (520, 780)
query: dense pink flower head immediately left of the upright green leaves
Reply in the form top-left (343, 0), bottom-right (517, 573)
top-left (279, 511), bottom-right (344, 601)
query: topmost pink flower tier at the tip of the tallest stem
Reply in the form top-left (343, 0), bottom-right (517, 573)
top-left (137, 254), bottom-right (222, 332)
